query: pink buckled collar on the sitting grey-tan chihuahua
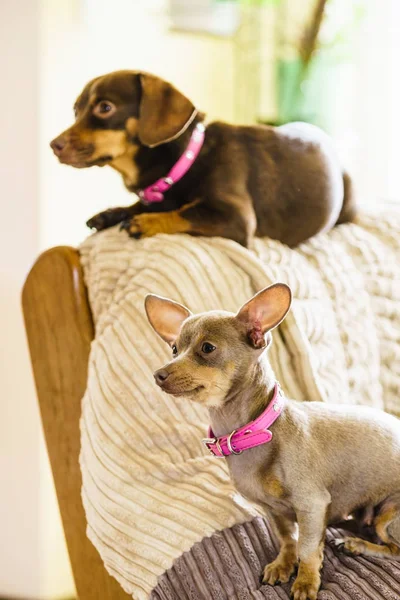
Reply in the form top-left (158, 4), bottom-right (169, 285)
top-left (202, 382), bottom-right (285, 458)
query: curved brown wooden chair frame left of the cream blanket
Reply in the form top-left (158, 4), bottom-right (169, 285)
top-left (22, 246), bottom-right (130, 600)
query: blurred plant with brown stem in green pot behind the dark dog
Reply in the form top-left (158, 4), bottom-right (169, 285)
top-left (214, 0), bottom-right (366, 126)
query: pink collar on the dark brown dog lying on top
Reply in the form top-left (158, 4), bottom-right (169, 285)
top-left (138, 123), bottom-right (205, 204)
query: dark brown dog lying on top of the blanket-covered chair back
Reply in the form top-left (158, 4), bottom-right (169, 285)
top-left (51, 71), bottom-right (355, 246)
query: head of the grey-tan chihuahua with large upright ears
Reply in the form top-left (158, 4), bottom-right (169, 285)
top-left (145, 283), bottom-right (291, 408)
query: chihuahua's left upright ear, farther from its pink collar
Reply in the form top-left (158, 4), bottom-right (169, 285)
top-left (144, 294), bottom-right (192, 345)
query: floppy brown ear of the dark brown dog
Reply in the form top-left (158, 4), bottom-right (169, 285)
top-left (138, 73), bottom-right (197, 148)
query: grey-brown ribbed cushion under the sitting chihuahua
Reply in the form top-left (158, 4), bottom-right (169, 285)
top-left (150, 518), bottom-right (400, 600)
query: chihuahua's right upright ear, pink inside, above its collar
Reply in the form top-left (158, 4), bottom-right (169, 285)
top-left (236, 283), bottom-right (292, 348)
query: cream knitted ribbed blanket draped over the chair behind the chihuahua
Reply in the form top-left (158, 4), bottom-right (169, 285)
top-left (81, 213), bottom-right (400, 600)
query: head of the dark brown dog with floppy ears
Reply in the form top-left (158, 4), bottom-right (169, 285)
top-left (50, 71), bottom-right (197, 185)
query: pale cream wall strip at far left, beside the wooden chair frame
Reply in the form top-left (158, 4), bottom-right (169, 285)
top-left (0, 0), bottom-right (72, 598)
